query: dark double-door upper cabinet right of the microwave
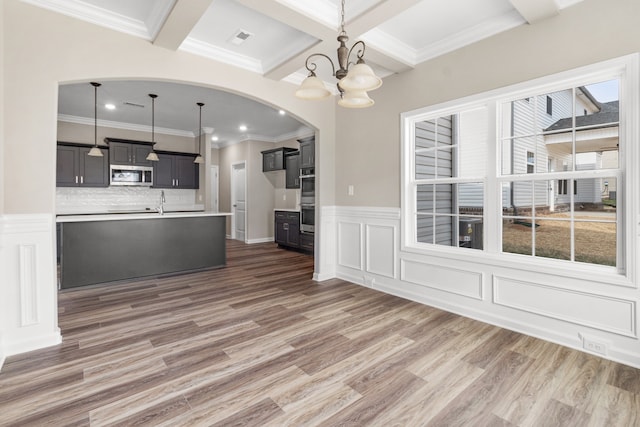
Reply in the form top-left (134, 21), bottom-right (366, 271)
top-left (153, 151), bottom-right (200, 189)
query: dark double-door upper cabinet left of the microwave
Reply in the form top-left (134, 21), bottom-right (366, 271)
top-left (56, 144), bottom-right (109, 187)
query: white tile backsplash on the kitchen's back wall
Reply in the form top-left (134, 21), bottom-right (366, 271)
top-left (56, 187), bottom-right (201, 214)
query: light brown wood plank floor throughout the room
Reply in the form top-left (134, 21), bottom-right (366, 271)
top-left (0, 241), bottom-right (640, 427)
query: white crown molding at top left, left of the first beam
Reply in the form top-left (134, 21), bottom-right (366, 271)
top-left (22, 0), bottom-right (154, 40)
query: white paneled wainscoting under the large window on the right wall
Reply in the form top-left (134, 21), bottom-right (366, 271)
top-left (316, 206), bottom-right (640, 367)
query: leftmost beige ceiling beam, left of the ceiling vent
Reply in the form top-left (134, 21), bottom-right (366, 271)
top-left (153, 0), bottom-right (213, 50)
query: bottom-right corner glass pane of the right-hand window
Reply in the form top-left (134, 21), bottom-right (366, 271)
top-left (574, 222), bottom-right (617, 266)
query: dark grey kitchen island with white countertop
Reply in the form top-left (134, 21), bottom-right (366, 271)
top-left (56, 212), bottom-right (230, 289)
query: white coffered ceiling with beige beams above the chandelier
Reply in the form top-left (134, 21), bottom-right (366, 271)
top-left (27, 0), bottom-right (582, 145)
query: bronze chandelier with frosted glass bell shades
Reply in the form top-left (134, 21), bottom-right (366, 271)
top-left (296, 0), bottom-right (382, 108)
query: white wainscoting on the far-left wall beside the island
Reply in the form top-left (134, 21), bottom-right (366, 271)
top-left (0, 214), bottom-right (62, 367)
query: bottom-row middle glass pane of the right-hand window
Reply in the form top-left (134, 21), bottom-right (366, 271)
top-left (534, 218), bottom-right (571, 260)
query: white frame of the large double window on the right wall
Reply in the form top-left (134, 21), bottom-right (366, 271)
top-left (400, 54), bottom-right (640, 287)
